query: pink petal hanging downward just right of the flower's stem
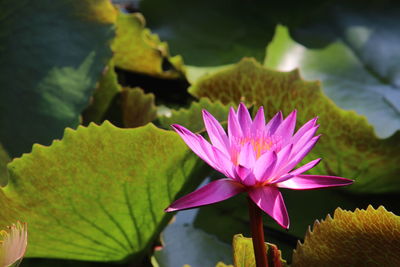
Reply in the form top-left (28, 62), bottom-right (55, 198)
top-left (249, 186), bottom-right (289, 229)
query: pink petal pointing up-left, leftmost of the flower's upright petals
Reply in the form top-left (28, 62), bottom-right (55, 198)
top-left (171, 124), bottom-right (222, 172)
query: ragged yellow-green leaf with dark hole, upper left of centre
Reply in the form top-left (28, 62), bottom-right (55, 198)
top-left (112, 12), bottom-right (184, 79)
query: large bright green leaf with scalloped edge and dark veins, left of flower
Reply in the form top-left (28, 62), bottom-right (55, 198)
top-left (0, 122), bottom-right (203, 261)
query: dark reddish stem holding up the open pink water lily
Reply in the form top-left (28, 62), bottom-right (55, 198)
top-left (247, 197), bottom-right (268, 267)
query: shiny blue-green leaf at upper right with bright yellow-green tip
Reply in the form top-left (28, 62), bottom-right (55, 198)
top-left (265, 25), bottom-right (400, 138)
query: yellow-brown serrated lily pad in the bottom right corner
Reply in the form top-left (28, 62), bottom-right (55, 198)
top-left (292, 206), bottom-right (400, 267)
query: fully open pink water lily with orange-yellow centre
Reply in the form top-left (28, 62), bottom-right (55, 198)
top-left (165, 103), bottom-right (353, 228)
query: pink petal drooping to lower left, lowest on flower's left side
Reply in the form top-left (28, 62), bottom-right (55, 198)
top-left (165, 178), bottom-right (245, 212)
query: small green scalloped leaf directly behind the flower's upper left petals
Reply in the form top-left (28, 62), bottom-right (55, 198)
top-left (158, 98), bottom-right (229, 132)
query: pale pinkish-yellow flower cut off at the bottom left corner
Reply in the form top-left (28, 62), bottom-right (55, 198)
top-left (0, 222), bottom-right (28, 267)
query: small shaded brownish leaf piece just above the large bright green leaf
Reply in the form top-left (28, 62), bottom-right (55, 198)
top-left (121, 88), bottom-right (157, 128)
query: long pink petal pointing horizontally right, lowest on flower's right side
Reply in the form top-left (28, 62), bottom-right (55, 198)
top-left (276, 175), bottom-right (354, 190)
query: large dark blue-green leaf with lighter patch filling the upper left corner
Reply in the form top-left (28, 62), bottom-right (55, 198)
top-left (0, 0), bottom-right (116, 157)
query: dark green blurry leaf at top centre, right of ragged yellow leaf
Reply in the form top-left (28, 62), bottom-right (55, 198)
top-left (140, 0), bottom-right (275, 66)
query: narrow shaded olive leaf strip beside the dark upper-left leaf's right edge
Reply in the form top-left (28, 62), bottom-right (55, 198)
top-left (83, 60), bottom-right (122, 125)
